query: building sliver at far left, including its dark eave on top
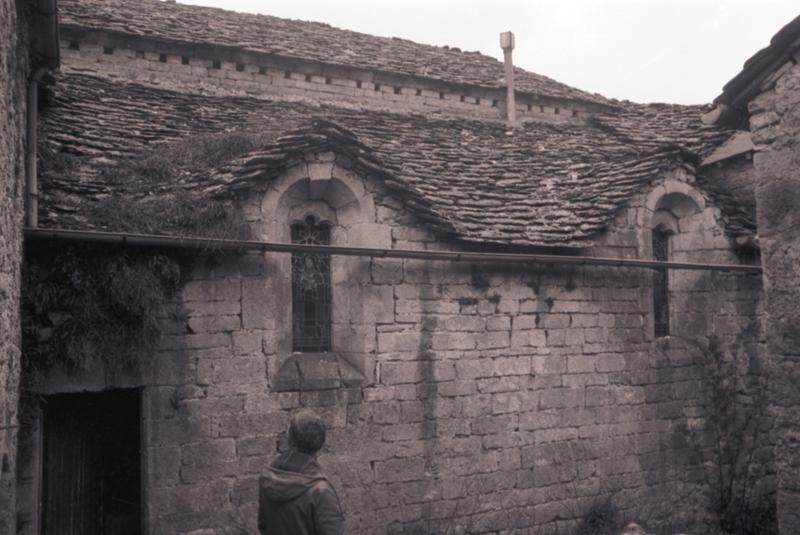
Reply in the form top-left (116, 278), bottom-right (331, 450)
top-left (0, 0), bottom-right (58, 533)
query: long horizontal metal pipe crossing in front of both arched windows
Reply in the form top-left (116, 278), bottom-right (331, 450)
top-left (24, 228), bottom-right (761, 273)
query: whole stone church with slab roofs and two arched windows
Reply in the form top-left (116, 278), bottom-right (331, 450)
top-left (4, 0), bottom-right (797, 535)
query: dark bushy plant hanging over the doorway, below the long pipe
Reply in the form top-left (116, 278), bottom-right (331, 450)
top-left (22, 244), bottom-right (186, 371)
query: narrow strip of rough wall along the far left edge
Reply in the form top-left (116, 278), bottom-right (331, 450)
top-left (0, 0), bottom-right (27, 533)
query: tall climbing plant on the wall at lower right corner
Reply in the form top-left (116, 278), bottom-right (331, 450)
top-left (701, 337), bottom-right (777, 535)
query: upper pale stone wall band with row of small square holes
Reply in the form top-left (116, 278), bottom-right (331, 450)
top-left (61, 28), bottom-right (602, 122)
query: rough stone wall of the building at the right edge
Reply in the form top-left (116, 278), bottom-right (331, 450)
top-left (749, 60), bottom-right (800, 534)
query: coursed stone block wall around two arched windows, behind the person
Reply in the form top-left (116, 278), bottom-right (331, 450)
top-left (18, 154), bottom-right (759, 534)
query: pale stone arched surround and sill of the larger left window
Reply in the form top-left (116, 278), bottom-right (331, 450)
top-left (243, 153), bottom-right (394, 391)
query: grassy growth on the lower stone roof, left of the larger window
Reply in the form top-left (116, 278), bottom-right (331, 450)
top-left (39, 131), bottom-right (262, 239)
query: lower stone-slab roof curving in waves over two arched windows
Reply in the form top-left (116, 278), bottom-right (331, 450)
top-left (41, 74), bottom-right (744, 247)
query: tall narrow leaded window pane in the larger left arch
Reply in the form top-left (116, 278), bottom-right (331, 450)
top-left (291, 216), bottom-right (331, 353)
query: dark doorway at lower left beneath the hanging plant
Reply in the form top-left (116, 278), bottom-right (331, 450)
top-left (42, 390), bottom-right (142, 535)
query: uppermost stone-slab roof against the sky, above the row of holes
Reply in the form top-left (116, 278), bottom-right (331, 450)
top-left (58, 0), bottom-right (617, 106)
